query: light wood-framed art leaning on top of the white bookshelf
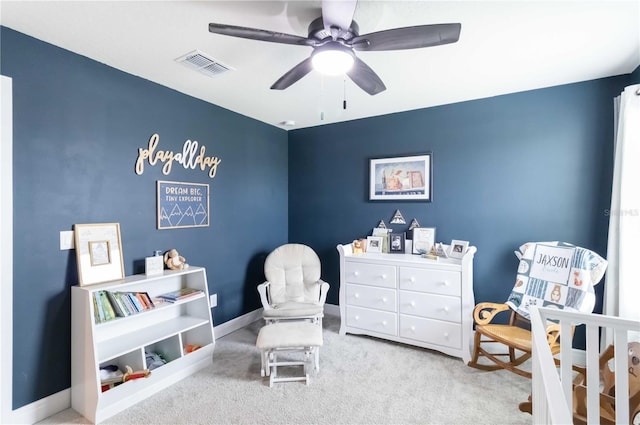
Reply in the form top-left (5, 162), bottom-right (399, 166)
top-left (73, 223), bottom-right (124, 286)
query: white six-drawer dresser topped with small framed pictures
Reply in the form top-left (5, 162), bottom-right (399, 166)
top-left (337, 244), bottom-right (476, 363)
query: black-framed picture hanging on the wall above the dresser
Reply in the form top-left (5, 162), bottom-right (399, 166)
top-left (369, 152), bottom-right (433, 202)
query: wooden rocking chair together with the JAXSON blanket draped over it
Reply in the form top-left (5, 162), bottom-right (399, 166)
top-left (469, 242), bottom-right (607, 378)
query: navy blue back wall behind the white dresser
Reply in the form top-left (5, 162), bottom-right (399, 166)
top-left (289, 75), bottom-right (629, 311)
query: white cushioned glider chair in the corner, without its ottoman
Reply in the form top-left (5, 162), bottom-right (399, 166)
top-left (258, 244), bottom-right (329, 326)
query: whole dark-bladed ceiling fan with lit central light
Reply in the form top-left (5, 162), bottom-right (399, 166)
top-left (209, 0), bottom-right (461, 95)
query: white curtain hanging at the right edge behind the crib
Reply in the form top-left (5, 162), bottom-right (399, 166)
top-left (603, 84), bottom-right (640, 346)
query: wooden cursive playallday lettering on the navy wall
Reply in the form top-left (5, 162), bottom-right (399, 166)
top-left (136, 133), bottom-right (222, 178)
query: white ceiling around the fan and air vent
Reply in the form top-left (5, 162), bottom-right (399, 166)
top-left (0, 0), bottom-right (640, 129)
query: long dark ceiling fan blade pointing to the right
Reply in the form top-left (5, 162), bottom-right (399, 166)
top-left (349, 23), bottom-right (462, 51)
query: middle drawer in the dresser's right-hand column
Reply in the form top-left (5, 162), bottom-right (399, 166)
top-left (399, 291), bottom-right (462, 323)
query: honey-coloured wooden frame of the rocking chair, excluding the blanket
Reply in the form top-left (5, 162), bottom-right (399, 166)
top-left (469, 302), bottom-right (573, 378)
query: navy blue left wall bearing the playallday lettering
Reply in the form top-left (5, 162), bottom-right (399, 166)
top-left (1, 28), bottom-right (288, 408)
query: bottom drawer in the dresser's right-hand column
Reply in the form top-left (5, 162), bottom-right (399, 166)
top-left (400, 314), bottom-right (462, 349)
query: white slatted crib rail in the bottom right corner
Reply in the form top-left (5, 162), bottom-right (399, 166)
top-left (531, 307), bottom-right (640, 425)
